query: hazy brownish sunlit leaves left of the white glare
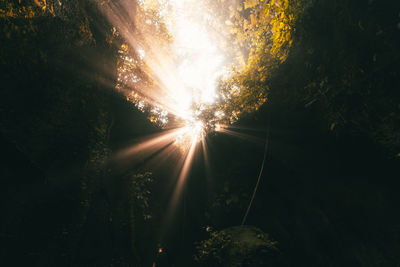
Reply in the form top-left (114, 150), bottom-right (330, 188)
top-left (113, 1), bottom-right (172, 126)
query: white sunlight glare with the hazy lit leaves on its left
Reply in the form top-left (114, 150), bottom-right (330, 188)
top-left (111, 0), bottom-right (227, 143)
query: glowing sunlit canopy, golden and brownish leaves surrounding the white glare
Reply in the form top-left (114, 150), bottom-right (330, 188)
top-left (111, 0), bottom-right (304, 130)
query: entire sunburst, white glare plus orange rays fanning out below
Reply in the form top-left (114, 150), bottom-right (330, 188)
top-left (97, 0), bottom-right (242, 241)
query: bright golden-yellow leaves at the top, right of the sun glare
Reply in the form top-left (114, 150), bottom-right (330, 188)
top-left (229, 0), bottom-right (304, 62)
